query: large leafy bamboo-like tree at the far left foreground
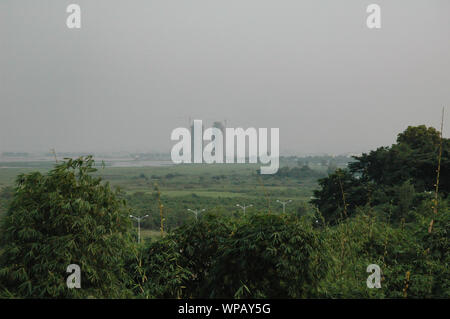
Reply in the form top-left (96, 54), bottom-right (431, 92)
top-left (0, 156), bottom-right (131, 298)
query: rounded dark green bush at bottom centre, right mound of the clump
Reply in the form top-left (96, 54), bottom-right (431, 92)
top-left (208, 214), bottom-right (327, 298)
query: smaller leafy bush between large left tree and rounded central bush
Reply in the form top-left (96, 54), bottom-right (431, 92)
top-left (143, 213), bottom-right (232, 298)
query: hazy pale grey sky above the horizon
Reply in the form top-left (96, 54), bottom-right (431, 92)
top-left (0, 0), bottom-right (450, 154)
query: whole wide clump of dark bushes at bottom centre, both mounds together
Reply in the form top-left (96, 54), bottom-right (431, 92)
top-left (137, 214), bottom-right (327, 298)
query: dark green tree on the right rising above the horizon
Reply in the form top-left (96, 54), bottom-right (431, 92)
top-left (311, 125), bottom-right (450, 223)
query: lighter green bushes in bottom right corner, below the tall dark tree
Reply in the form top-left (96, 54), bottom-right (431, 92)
top-left (321, 201), bottom-right (450, 298)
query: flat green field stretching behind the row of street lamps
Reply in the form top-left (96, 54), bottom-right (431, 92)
top-left (0, 162), bottom-right (327, 237)
